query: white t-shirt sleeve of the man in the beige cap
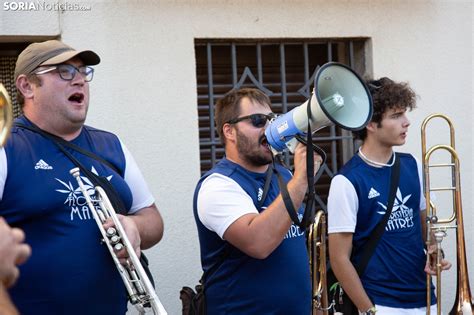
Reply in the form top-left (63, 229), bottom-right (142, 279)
top-left (120, 141), bottom-right (155, 214)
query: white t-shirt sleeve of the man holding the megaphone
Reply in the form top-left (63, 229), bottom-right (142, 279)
top-left (197, 173), bottom-right (258, 239)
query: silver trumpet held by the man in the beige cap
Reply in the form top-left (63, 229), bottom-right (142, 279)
top-left (70, 167), bottom-right (168, 315)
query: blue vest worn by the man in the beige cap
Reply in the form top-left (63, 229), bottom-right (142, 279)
top-left (0, 118), bottom-right (132, 315)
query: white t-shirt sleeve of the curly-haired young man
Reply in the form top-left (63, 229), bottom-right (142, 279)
top-left (328, 175), bottom-right (359, 233)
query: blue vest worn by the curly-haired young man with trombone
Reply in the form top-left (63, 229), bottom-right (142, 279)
top-left (340, 153), bottom-right (436, 308)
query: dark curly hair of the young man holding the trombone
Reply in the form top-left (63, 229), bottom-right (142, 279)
top-left (354, 77), bottom-right (417, 140)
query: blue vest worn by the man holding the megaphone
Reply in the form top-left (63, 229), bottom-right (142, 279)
top-left (194, 158), bottom-right (311, 315)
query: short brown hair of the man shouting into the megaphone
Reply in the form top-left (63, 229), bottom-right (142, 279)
top-left (215, 88), bottom-right (271, 146)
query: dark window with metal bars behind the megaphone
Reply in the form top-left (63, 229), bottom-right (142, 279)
top-left (195, 38), bottom-right (367, 209)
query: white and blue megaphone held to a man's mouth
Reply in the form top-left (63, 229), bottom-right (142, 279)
top-left (265, 62), bottom-right (372, 152)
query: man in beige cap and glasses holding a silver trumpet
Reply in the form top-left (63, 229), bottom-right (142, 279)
top-left (0, 40), bottom-right (163, 315)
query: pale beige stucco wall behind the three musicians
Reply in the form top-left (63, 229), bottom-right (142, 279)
top-left (0, 0), bottom-right (474, 314)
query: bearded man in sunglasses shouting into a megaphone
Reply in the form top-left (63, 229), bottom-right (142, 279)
top-left (194, 88), bottom-right (321, 315)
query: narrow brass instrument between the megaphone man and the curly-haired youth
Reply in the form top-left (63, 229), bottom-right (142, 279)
top-left (307, 210), bottom-right (333, 315)
